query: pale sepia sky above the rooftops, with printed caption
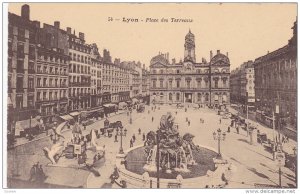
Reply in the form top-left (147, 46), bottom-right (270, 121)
top-left (9, 3), bottom-right (297, 70)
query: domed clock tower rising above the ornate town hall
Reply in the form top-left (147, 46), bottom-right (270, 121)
top-left (184, 30), bottom-right (196, 63)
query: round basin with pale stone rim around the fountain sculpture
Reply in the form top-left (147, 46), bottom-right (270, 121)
top-left (116, 145), bottom-right (230, 188)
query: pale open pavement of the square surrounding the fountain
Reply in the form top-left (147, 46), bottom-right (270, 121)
top-left (8, 106), bottom-right (296, 188)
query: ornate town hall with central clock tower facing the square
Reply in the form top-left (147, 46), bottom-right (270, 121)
top-left (150, 31), bottom-right (230, 105)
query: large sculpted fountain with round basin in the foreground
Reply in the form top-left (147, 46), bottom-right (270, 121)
top-left (116, 113), bottom-right (232, 188)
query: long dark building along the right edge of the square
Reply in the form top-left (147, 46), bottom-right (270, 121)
top-left (254, 21), bottom-right (297, 128)
